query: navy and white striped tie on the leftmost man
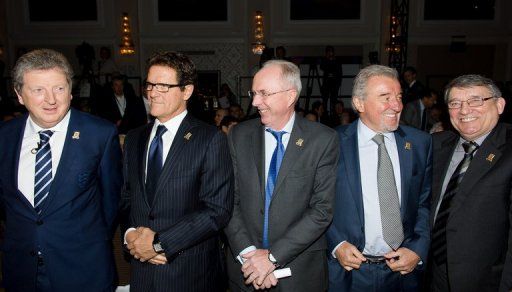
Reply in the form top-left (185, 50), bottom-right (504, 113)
top-left (34, 130), bottom-right (53, 214)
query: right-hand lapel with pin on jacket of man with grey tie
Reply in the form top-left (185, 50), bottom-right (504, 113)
top-left (395, 128), bottom-right (414, 221)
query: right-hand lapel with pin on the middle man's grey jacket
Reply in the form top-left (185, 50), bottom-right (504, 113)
top-left (272, 116), bottom-right (309, 197)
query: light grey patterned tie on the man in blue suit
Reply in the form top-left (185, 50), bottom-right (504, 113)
top-left (372, 134), bottom-right (404, 250)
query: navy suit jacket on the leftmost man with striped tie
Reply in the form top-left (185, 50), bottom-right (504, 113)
top-left (0, 110), bottom-right (122, 292)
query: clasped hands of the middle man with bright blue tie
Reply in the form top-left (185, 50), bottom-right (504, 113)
top-left (242, 249), bottom-right (275, 289)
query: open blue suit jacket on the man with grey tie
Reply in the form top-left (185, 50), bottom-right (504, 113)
top-left (327, 120), bottom-right (432, 291)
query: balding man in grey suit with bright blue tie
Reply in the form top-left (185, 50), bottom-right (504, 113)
top-left (225, 60), bottom-right (339, 291)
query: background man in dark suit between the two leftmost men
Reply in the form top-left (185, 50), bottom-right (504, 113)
top-left (97, 75), bottom-right (147, 134)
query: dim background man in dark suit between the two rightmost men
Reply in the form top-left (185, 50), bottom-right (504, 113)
top-left (400, 89), bottom-right (437, 132)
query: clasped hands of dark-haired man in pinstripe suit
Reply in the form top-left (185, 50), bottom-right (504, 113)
top-left (126, 227), bottom-right (167, 265)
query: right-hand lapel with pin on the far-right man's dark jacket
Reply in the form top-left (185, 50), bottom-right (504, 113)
top-left (450, 125), bottom-right (506, 216)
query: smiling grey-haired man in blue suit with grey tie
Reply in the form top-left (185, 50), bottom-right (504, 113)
top-left (327, 65), bottom-right (432, 292)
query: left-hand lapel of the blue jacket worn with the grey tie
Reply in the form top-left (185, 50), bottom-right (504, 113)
top-left (338, 120), bottom-right (364, 223)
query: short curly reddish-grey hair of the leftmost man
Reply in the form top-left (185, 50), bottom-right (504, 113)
top-left (12, 49), bottom-right (73, 93)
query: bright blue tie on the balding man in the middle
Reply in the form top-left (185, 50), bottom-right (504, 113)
top-left (263, 129), bottom-right (286, 248)
